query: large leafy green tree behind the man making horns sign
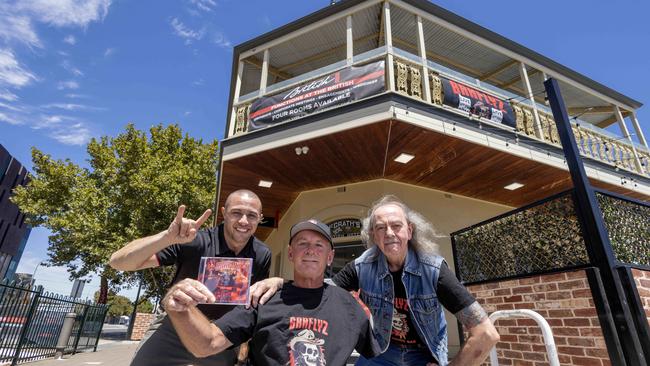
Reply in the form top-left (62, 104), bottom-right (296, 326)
top-left (12, 124), bottom-right (218, 303)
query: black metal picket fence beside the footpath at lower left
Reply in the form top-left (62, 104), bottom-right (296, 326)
top-left (0, 281), bottom-right (108, 365)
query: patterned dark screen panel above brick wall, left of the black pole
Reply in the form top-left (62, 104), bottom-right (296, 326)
top-left (453, 194), bottom-right (589, 283)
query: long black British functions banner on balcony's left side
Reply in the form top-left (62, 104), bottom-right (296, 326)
top-left (248, 60), bottom-right (385, 131)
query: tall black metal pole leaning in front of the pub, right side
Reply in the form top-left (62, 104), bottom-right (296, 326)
top-left (544, 78), bottom-right (646, 365)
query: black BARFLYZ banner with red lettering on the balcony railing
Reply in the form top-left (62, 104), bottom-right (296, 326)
top-left (440, 77), bottom-right (516, 127)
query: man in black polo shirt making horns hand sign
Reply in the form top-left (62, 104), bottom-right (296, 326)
top-left (110, 190), bottom-right (271, 366)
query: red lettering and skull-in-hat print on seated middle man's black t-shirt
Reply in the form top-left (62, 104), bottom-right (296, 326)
top-left (288, 316), bottom-right (328, 366)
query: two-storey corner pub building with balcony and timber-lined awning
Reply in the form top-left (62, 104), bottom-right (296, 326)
top-left (217, 0), bottom-right (650, 365)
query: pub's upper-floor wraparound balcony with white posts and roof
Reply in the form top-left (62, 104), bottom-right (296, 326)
top-left (226, 1), bottom-right (650, 181)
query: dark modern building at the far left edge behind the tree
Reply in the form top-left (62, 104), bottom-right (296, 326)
top-left (0, 145), bottom-right (31, 280)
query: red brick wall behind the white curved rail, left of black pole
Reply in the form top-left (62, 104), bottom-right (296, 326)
top-left (468, 270), bottom-right (608, 366)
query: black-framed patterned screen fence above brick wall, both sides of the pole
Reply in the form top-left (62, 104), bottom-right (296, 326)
top-left (451, 190), bottom-right (650, 284)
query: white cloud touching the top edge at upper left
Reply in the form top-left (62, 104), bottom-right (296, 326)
top-left (16, 0), bottom-right (111, 27)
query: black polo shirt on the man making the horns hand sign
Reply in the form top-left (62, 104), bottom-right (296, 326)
top-left (156, 224), bottom-right (271, 319)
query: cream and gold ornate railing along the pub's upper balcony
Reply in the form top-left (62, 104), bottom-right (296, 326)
top-left (232, 46), bottom-right (650, 176)
